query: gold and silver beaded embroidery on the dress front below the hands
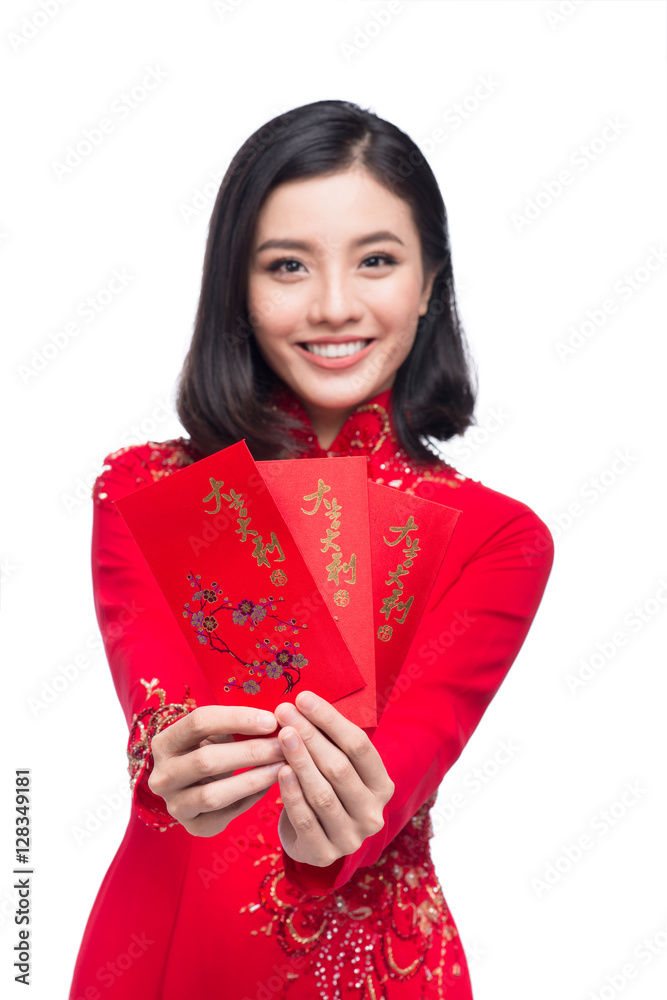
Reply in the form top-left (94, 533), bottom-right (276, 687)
top-left (240, 793), bottom-right (462, 1000)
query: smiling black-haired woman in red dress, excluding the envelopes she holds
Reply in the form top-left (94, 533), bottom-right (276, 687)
top-left (70, 101), bottom-right (553, 1000)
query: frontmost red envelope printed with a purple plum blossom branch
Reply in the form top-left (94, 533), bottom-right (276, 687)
top-left (116, 441), bottom-right (364, 710)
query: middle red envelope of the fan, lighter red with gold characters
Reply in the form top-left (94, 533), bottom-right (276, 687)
top-left (257, 457), bottom-right (377, 727)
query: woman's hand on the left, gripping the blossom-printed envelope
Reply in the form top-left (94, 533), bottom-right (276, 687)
top-left (148, 705), bottom-right (285, 837)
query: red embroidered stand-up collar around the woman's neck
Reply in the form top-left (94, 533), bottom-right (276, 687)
top-left (271, 382), bottom-right (396, 458)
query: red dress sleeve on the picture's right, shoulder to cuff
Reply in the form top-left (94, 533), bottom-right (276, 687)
top-left (283, 484), bottom-right (553, 895)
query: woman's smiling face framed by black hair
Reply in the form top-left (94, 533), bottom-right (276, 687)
top-left (248, 168), bottom-right (433, 416)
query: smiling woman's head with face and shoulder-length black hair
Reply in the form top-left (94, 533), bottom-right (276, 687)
top-left (178, 101), bottom-right (475, 463)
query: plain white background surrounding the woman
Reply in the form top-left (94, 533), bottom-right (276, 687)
top-left (0, 0), bottom-right (667, 1000)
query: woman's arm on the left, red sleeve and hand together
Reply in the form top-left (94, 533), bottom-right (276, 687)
top-left (92, 442), bottom-right (284, 836)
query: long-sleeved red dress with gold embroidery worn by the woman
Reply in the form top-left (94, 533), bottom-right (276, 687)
top-left (70, 389), bottom-right (553, 1000)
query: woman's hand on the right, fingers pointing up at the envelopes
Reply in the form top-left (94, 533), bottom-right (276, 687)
top-left (275, 691), bottom-right (394, 867)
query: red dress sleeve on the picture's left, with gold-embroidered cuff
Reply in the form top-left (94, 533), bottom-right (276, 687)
top-left (91, 445), bottom-right (215, 831)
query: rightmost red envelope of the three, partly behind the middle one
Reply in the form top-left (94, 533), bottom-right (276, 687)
top-left (368, 482), bottom-right (461, 725)
